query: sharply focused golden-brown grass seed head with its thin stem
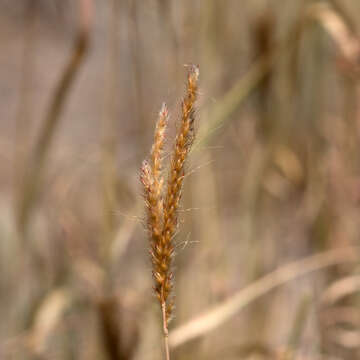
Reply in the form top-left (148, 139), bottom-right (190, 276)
top-left (141, 66), bottom-right (199, 359)
